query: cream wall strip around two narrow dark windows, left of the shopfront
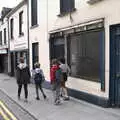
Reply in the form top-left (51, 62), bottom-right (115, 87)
top-left (29, 0), bottom-right (49, 80)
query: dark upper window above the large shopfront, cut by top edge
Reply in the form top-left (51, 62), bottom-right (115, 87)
top-left (60, 0), bottom-right (75, 14)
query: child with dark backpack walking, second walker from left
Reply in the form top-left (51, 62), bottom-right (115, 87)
top-left (34, 63), bottom-right (46, 100)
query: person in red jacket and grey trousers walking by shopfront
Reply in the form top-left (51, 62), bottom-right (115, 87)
top-left (50, 59), bottom-right (62, 105)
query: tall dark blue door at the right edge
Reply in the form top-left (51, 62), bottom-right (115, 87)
top-left (110, 25), bottom-right (120, 106)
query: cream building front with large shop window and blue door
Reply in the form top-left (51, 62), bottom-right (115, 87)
top-left (48, 0), bottom-right (120, 107)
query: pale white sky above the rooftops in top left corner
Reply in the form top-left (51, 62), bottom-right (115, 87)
top-left (0, 0), bottom-right (21, 11)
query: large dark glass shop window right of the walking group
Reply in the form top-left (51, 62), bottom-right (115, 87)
top-left (68, 30), bottom-right (104, 82)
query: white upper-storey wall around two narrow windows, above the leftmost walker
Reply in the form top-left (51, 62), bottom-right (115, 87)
top-left (9, 4), bottom-right (28, 51)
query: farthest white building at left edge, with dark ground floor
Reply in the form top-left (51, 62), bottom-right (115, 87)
top-left (0, 7), bottom-right (11, 73)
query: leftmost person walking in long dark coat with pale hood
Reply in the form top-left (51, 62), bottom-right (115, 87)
top-left (16, 57), bottom-right (30, 102)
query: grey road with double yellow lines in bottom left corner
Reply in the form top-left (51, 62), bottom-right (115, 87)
top-left (0, 91), bottom-right (36, 120)
